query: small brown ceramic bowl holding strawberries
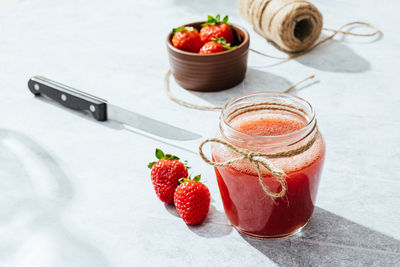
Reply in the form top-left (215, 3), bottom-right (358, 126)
top-left (167, 21), bottom-right (250, 92)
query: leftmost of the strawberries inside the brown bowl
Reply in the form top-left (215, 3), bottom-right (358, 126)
top-left (172, 26), bottom-right (203, 53)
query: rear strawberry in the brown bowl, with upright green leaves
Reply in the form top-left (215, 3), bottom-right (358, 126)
top-left (200, 14), bottom-right (234, 44)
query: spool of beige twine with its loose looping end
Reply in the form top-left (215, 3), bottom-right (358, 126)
top-left (238, 0), bottom-right (379, 59)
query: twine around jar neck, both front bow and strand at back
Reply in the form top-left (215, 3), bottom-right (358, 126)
top-left (199, 102), bottom-right (319, 198)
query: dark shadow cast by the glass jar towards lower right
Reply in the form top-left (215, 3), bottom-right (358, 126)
top-left (242, 207), bottom-right (400, 266)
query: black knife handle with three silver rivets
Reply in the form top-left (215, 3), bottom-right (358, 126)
top-left (28, 76), bottom-right (107, 121)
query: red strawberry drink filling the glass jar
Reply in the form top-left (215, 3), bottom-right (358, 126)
top-left (213, 112), bottom-right (325, 237)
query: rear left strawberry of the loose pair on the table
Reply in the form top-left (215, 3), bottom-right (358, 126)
top-left (148, 149), bottom-right (189, 204)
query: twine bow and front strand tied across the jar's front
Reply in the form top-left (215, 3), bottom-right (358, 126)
top-left (199, 126), bottom-right (319, 198)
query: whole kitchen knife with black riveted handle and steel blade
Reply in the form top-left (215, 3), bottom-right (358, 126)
top-left (28, 76), bottom-right (201, 141)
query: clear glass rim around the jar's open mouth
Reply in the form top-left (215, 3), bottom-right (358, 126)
top-left (220, 91), bottom-right (316, 140)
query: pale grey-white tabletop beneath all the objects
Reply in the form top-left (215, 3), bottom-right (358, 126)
top-left (0, 0), bottom-right (400, 267)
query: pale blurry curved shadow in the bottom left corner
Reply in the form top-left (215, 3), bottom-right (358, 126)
top-left (0, 129), bottom-right (108, 267)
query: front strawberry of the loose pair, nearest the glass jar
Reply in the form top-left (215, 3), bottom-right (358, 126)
top-left (174, 175), bottom-right (210, 225)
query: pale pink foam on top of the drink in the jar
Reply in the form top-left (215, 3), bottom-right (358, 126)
top-left (213, 110), bottom-right (324, 175)
